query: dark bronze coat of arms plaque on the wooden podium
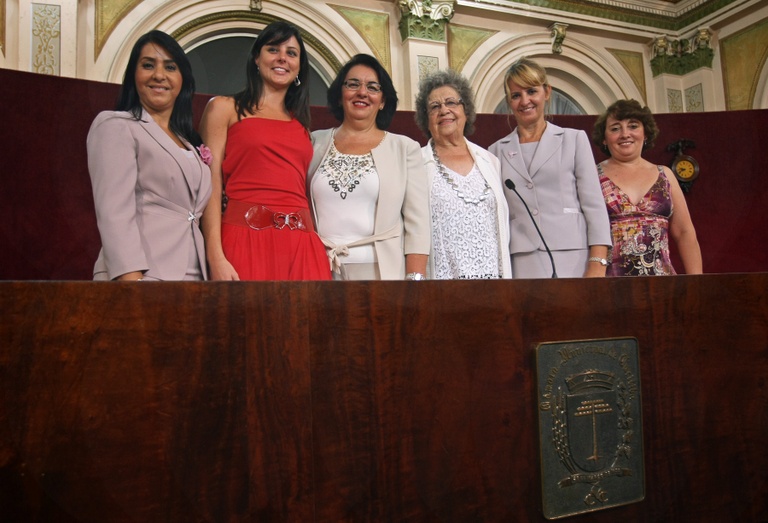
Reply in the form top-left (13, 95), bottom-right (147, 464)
top-left (536, 338), bottom-right (645, 519)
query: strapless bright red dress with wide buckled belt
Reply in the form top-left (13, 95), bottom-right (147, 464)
top-left (221, 118), bottom-right (331, 280)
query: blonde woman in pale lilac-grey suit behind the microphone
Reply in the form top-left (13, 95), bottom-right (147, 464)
top-left (489, 58), bottom-right (611, 278)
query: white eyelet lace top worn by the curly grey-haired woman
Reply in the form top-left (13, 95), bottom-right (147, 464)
top-left (430, 165), bottom-right (502, 280)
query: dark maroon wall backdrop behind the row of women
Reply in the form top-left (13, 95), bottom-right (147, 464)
top-left (0, 69), bottom-right (768, 280)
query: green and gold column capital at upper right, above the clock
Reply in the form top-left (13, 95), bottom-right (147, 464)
top-left (651, 27), bottom-right (715, 76)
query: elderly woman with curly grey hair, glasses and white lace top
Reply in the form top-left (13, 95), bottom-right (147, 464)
top-left (415, 70), bottom-right (512, 280)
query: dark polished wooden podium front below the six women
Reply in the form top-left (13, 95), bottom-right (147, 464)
top-left (0, 273), bottom-right (768, 523)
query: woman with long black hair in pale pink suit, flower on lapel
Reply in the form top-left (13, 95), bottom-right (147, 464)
top-left (87, 31), bottom-right (211, 281)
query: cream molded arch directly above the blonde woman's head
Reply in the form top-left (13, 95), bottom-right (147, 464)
top-left (465, 33), bottom-right (644, 114)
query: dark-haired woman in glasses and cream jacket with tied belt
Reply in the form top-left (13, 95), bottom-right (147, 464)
top-left (307, 54), bottom-right (429, 280)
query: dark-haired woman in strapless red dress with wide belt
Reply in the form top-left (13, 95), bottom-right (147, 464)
top-left (200, 21), bottom-right (331, 280)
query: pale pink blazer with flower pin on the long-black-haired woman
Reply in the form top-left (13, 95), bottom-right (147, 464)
top-left (87, 111), bottom-right (211, 280)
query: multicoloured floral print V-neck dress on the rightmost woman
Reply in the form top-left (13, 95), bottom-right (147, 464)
top-left (597, 164), bottom-right (676, 276)
